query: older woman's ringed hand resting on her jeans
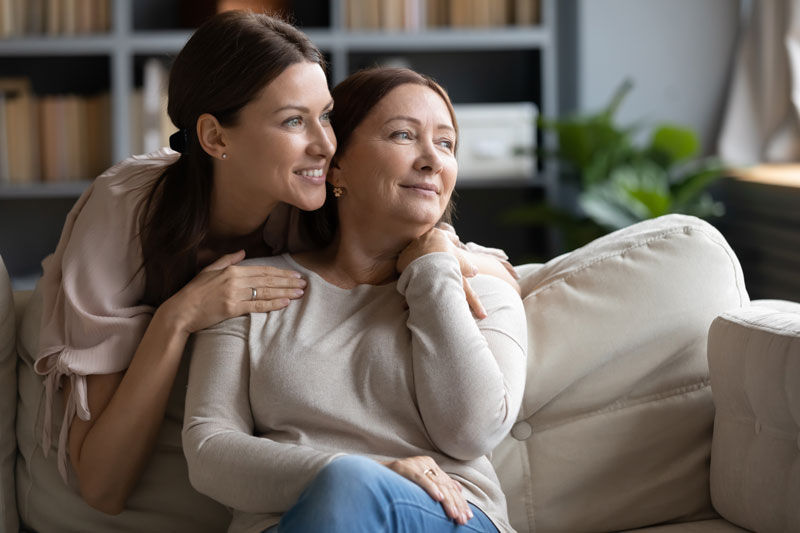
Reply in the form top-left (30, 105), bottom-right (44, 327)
top-left (381, 455), bottom-right (472, 525)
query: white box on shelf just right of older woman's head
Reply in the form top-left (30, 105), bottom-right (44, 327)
top-left (454, 102), bottom-right (538, 181)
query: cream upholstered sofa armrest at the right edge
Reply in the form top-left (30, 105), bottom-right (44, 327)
top-left (708, 300), bottom-right (800, 532)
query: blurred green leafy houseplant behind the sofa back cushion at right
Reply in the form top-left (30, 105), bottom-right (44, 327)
top-left (506, 80), bottom-right (724, 249)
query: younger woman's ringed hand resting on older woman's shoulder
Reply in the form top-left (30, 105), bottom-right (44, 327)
top-left (159, 250), bottom-right (306, 334)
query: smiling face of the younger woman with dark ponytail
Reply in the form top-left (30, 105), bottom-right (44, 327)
top-left (223, 62), bottom-right (336, 210)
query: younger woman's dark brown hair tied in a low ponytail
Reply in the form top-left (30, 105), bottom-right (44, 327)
top-left (139, 11), bottom-right (325, 306)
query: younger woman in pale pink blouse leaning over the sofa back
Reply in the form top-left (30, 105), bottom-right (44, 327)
top-left (36, 12), bottom-right (336, 513)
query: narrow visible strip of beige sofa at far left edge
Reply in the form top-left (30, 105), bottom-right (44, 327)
top-left (0, 257), bottom-right (19, 531)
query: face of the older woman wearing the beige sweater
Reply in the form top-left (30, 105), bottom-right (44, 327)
top-left (334, 84), bottom-right (458, 233)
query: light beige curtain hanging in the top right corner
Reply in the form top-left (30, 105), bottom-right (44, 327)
top-left (718, 0), bottom-right (800, 165)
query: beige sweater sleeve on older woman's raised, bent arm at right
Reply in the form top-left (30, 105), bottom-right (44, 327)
top-left (397, 253), bottom-right (527, 460)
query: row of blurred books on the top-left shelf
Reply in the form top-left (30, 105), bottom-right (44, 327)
top-left (0, 0), bottom-right (111, 39)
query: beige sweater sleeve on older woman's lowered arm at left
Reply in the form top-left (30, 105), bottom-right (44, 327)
top-left (183, 316), bottom-right (343, 513)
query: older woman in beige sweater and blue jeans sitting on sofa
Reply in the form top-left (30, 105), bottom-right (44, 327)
top-left (183, 69), bottom-right (526, 532)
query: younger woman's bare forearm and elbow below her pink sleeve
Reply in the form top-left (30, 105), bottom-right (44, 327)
top-left (70, 312), bottom-right (188, 514)
